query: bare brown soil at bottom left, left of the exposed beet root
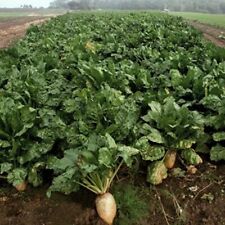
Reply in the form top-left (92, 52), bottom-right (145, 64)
top-left (0, 185), bottom-right (102, 225)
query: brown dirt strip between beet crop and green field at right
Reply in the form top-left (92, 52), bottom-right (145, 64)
top-left (190, 21), bottom-right (225, 48)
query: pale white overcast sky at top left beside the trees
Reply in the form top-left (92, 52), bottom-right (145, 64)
top-left (0, 0), bottom-right (52, 8)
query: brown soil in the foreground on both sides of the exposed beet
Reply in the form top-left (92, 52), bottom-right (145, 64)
top-left (0, 164), bottom-right (225, 225)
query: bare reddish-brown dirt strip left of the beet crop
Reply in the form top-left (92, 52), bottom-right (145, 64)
top-left (0, 17), bottom-right (48, 48)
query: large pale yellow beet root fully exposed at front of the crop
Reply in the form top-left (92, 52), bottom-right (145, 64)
top-left (95, 193), bottom-right (116, 225)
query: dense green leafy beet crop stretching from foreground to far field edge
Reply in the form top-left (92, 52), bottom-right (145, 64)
top-left (0, 12), bottom-right (225, 225)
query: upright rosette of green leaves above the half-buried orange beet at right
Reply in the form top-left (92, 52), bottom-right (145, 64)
top-left (142, 97), bottom-right (203, 147)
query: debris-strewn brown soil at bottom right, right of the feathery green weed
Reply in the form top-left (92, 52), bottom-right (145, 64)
top-left (146, 164), bottom-right (225, 225)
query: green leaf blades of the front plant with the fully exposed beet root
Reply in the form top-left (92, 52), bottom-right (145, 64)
top-left (48, 133), bottom-right (139, 196)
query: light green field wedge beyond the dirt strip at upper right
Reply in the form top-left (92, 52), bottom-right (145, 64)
top-left (170, 12), bottom-right (225, 28)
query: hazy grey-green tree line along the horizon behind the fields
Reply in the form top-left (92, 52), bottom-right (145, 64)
top-left (50, 0), bottom-right (225, 13)
